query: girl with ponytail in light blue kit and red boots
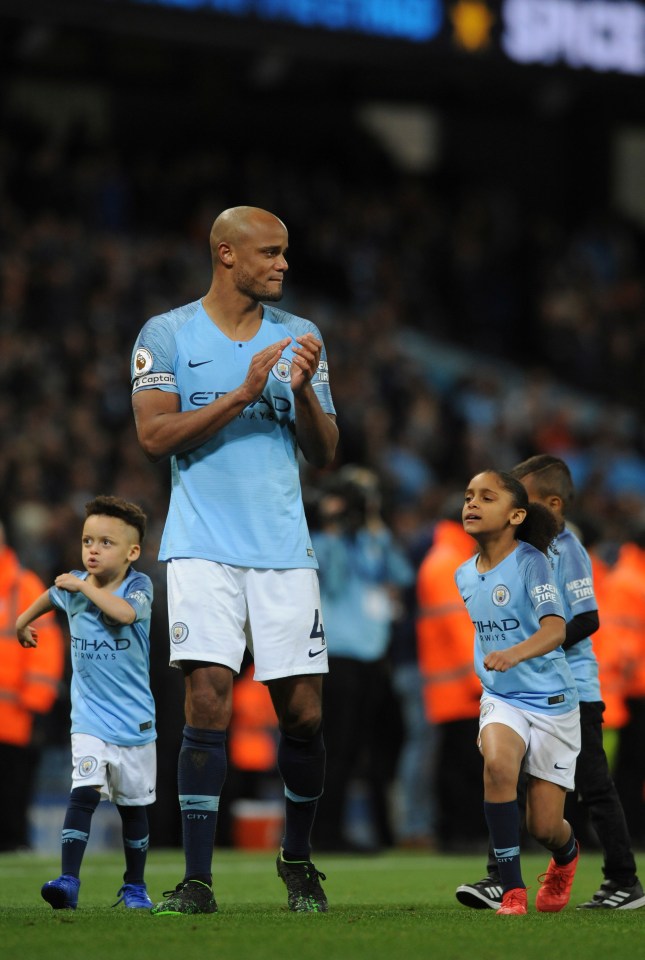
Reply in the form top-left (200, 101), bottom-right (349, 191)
top-left (455, 470), bottom-right (580, 915)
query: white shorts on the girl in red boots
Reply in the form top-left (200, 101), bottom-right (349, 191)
top-left (479, 694), bottom-right (580, 791)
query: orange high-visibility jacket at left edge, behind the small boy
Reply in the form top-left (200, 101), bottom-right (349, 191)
top-left (0, 547), bottom-right (65, 747)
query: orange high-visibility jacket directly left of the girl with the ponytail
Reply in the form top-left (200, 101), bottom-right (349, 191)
top-left (417, 520), bottom-right (482, 723)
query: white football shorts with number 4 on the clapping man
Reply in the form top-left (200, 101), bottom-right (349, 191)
top-left (168, 558), bottom-right (329, 682)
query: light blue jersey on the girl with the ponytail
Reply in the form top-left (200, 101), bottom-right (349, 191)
top-left (455, 540), bottom-right (578, 714)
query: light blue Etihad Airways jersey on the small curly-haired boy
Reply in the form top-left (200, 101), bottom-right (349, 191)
top-left (49, 568), bottom-right (157, 747)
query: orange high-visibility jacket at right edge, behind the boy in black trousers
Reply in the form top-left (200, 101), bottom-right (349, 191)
top-left (594, 543), bottom-right (645, 726)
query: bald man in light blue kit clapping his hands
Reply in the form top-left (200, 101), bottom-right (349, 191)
top-left (132, 206), bottom-right (338, 916)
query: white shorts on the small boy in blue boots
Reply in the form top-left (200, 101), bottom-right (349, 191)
top-left (72, 733), bottom-right (157, 807)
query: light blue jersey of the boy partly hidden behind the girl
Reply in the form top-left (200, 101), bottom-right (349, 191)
top-left (552, 527), bottom-right (602, 703)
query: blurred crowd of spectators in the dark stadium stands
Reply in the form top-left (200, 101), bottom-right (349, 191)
top-left (0, 101), bottom-right (645, 848)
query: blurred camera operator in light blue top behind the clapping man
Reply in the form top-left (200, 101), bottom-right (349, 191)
top-left (311, 464), bottom-right (414, 852)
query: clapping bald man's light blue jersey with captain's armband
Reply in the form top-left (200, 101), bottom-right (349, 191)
top-left (132, 301), bottom-right (335, 569)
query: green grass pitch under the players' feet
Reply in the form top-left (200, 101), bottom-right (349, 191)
top-left (0, 849), bottom-right (645, 960)
